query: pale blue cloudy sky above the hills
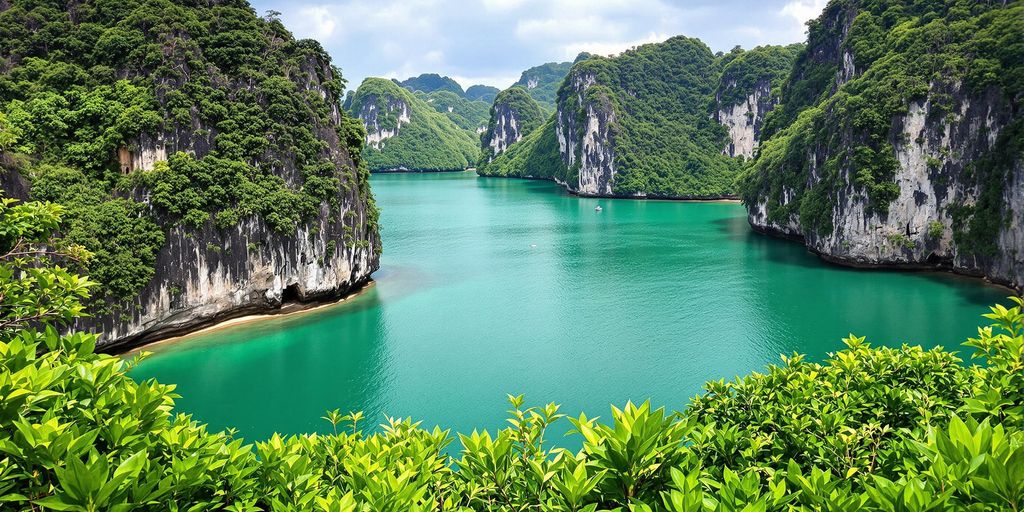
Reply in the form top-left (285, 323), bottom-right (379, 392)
top-left (252, 0), bottom-right (826, 88)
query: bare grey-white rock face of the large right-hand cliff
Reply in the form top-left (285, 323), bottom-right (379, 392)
top-left (748, 84), bottom-right (1024, 289)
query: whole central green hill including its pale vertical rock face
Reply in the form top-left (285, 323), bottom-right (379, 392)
top-left (484, 37), bottom-right (791, 198)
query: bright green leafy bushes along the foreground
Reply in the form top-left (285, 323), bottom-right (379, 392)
top-left (0, 201), bottom-right (1024, 512)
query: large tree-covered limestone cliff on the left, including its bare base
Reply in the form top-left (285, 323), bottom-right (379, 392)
top-left (0, 0), bottom-right (381, 350)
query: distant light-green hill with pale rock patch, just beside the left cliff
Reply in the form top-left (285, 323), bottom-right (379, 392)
top-left (350, 78), bottom-right (479, 171)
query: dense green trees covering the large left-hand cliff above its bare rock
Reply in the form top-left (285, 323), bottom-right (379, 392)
top-left (0, 0), bottom-right (375, 303)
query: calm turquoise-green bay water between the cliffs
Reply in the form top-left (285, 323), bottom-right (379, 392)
top-left (133, 173), bottom-right (1007, 438)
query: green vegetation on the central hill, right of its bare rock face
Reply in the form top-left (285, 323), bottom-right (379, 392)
top-left (581, 37), bottom-right (739, 196)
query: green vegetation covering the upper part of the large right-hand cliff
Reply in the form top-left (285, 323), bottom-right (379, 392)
top-left (741, 0), bottom-right (1024, 235)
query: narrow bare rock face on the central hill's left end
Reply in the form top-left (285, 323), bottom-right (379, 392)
top-left (556, 72), bottom-right (615, 196)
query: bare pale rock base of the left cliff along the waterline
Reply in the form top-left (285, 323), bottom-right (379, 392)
top-left (92, 204), bottom-right (380, 350)
